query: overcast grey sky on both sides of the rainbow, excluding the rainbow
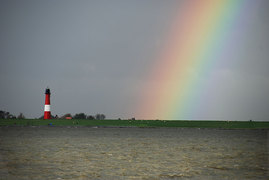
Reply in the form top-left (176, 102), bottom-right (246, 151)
top-left (0, 0), bottom-right (269, 120)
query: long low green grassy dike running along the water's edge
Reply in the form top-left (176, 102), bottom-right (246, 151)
top-left (0, 119), bottom-right (269, 129)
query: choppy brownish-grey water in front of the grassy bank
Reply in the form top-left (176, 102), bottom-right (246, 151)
top-left (0, 127), bottom-right (269, 179)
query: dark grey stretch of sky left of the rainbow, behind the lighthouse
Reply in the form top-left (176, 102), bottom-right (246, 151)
top-left (0, 1), bottom-right (179, 117)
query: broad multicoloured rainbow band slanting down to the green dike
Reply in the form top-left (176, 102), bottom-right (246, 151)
top-left (137, 0), bottom-right (254, 120)
